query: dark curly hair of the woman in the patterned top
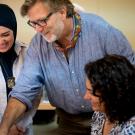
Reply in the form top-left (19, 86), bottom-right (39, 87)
top-left (85, 55), bottom-right (135, 123)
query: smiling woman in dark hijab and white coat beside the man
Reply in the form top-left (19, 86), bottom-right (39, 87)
top-left (0, 4), bottom-right (41, 135)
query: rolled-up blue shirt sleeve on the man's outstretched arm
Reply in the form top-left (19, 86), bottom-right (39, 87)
top-left (9, 37), bottom-right (43, 109)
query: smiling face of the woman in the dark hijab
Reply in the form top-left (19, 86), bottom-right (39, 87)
top-left (0, 26), bottom-right (14, 53)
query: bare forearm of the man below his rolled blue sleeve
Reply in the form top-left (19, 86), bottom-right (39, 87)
top-left (0, 98), bottom-right (26, 135)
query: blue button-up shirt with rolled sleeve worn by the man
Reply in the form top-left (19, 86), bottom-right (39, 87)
top-left (11, 13), bottom-right (135, 114)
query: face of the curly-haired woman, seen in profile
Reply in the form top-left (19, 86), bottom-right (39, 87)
top-left (84, 79), bottom-right (105, 112)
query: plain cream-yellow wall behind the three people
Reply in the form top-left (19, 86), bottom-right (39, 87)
top-left (0, 0), bottom-right (135, 48)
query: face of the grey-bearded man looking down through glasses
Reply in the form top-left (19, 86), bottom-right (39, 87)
top-left (28, 2), bottom-right (66, 42)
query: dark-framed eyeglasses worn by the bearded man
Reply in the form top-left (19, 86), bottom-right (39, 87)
top-left (27, 12), bottom-right (54, 28)
